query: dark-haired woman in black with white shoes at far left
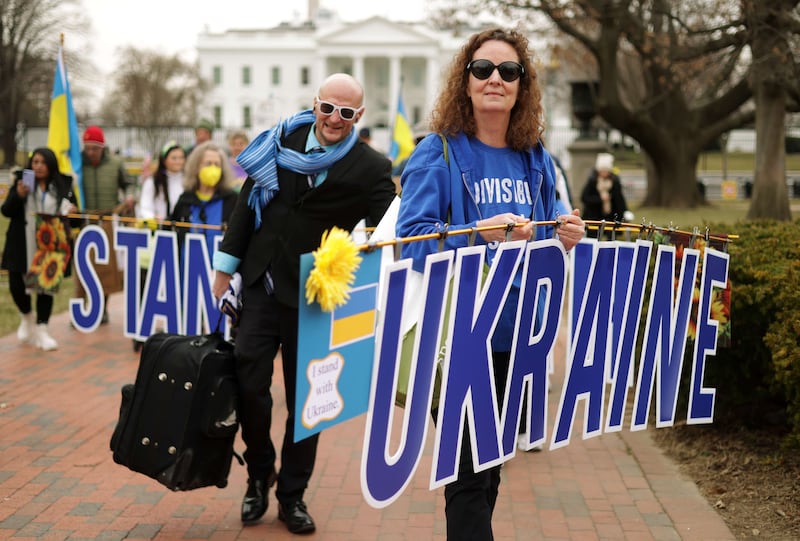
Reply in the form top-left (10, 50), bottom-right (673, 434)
top-left (2, 147), bottom-right (75, 351)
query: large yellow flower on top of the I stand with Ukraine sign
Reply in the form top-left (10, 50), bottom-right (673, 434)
top-left (306, 227), bottom-right (361, 312)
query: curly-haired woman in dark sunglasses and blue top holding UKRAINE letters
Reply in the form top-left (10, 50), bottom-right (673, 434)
top-left (396, 28), bottom-right (584, 541)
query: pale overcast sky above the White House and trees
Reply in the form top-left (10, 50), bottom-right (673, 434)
top-left (82, 0), bottom-right (424, 74)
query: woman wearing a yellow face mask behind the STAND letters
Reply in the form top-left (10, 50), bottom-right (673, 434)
top-left (171, 141), bottom-right (237, 257)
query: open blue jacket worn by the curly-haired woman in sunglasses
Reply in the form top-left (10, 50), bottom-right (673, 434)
top-left (396, 133), bottom-right (557, 351)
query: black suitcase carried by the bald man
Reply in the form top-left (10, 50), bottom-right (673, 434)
top-left (111, 332), bottom-right (239, 490)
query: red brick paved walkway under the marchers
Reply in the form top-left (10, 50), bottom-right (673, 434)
top-left (0, 295), bottom-right (735, 541)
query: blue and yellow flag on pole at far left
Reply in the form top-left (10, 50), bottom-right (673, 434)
top-left (47, 39), bottom-right (85, 209)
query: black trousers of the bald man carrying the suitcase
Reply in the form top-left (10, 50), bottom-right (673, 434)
top-left (236, 281), bottom-right (319, 504)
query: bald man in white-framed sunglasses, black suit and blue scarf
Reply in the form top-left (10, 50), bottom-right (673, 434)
top-left (213, 73), bottom-right (395, 533)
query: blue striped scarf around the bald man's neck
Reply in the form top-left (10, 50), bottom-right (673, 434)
top-left (236, 109), bottom-right (358, 229)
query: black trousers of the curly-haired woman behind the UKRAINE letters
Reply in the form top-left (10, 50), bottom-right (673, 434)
top-left (444, 352), bottom-right (511, 541)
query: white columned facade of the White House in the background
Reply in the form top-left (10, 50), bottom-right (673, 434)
top-left (197, 10), bottom-right (472, 150)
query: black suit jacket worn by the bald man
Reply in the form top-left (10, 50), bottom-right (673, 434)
top-left (219, 124), bottom-right (396, 307)
